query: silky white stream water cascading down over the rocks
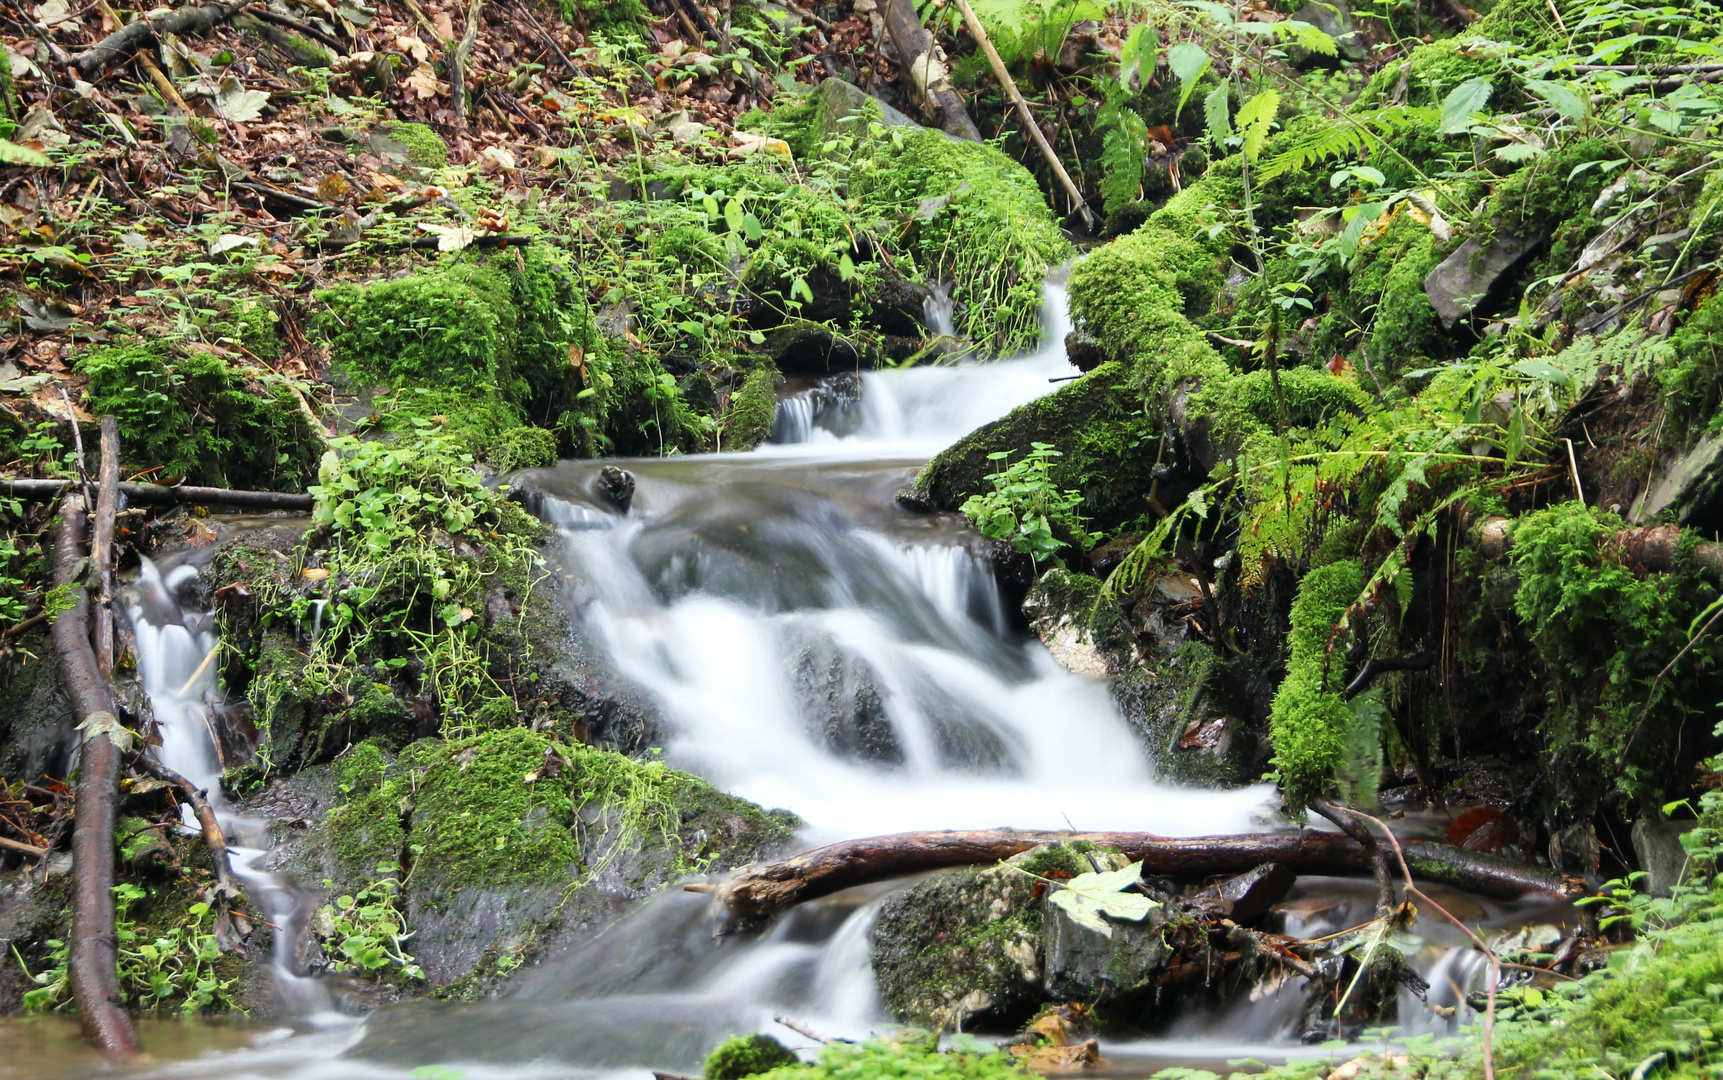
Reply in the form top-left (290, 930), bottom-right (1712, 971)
top-left (0, 286), bottom-right (1578, 1080)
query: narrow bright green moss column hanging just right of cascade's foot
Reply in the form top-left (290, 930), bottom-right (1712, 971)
top-left (1268, 560), bottom-right (1365, 808)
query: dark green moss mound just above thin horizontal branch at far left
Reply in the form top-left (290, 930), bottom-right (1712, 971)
top-left (78, 344), bottom-right (322, 491)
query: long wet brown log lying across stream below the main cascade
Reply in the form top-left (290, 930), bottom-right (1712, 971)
top-left (684, 829), bottom-right (1587, 923)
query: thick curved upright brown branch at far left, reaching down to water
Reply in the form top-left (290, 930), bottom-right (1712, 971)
top-left (53, 494), bottom-right (138, 1058)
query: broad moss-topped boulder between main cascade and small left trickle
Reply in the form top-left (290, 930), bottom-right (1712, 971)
top-left (311, 727), bottom-right (799, 996)
